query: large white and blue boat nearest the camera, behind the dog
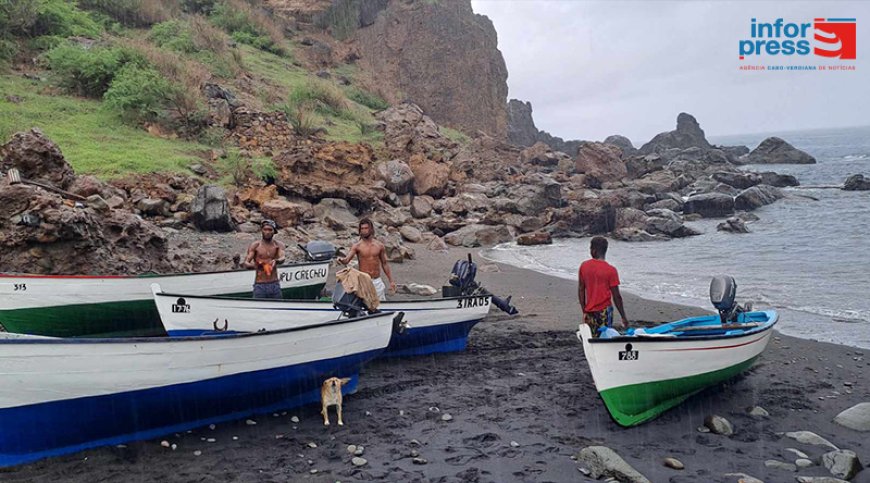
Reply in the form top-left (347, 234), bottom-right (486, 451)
top-left (0, 312), bottom-right (401, 466)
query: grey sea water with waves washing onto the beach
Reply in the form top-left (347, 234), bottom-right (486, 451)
top-left (484, 127), bottom-right (870, 348)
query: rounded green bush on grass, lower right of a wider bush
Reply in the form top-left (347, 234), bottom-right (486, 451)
top-left (103, 63), bottom-right (175, 122)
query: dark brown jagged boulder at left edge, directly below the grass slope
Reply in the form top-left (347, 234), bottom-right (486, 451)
top-left (0, 128), bottom-right (76, 190)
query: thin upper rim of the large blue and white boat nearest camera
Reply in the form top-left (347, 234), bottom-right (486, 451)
top-left (0, 311), bottom-right (399, 345)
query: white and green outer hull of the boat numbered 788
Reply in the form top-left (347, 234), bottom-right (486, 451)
top-left (578, 315), bottom-right (776, 426)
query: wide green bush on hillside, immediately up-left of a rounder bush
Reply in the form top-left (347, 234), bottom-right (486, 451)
top-left (45, 42), bottom-right (141, 97)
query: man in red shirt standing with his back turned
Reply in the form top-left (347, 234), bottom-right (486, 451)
top-left (577, 236), bottom-right (628, 337)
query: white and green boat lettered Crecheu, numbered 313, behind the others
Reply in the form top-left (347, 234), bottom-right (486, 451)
top-left (0, 261), bottom-right (329, 337)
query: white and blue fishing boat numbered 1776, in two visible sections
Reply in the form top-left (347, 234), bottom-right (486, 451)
top-left (153, 284), bottom-right (492, 357)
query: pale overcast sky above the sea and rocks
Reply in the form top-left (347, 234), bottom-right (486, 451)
top-left (472, 0), bottom-right (870, 146)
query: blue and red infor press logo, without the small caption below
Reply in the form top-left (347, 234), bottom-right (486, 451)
top-left (739, 18), bottom-right (857, 60)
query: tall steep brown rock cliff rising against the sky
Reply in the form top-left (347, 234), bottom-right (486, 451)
top-left (286, 0), bottom-right (507, 139)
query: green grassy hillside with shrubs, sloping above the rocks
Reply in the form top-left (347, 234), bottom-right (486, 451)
top-left (0, 0), bottom-right (387, 178)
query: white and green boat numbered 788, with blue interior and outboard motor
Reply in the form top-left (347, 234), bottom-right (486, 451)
top-left (577, 277), bottom-right (778, 427)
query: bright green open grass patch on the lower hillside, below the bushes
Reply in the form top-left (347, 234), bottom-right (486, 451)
top-left (0, 75), bottom-right (209, 179)
